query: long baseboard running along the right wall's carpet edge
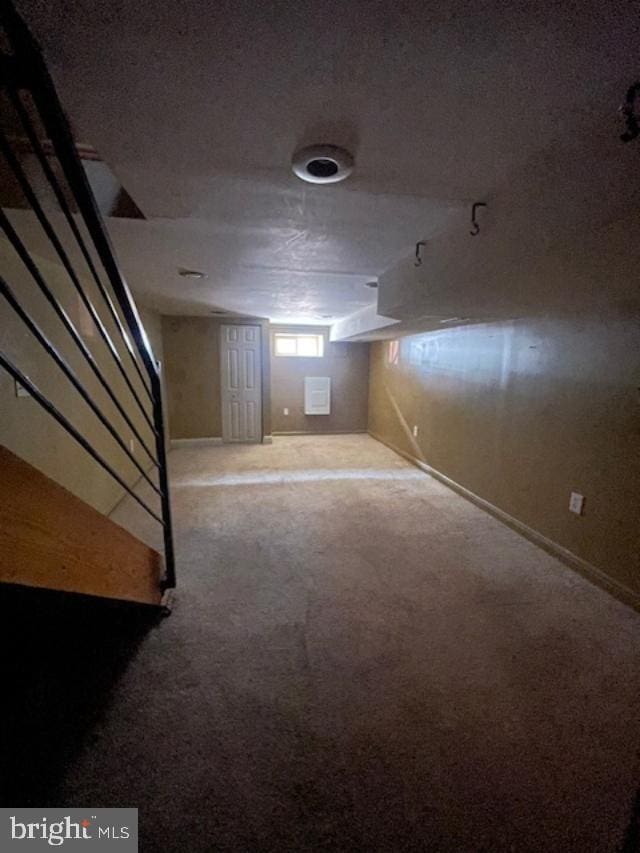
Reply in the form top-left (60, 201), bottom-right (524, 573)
top-left (369, 430), bottom-right (640, 611)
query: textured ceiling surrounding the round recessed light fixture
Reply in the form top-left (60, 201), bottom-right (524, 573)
top-left (19, 0), bottom-right (640, 322)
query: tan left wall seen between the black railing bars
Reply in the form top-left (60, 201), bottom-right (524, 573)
top-left (0, 238), bottom-right (157, 513)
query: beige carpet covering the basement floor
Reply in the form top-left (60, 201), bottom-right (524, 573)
top-left (91, 435), bottom-right (640, 853)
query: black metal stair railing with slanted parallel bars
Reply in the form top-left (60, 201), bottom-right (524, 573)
top-left (0, 0), bottom-right (175, 588)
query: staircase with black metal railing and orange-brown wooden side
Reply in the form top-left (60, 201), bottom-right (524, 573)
top-left (0, 0), bottom-right (175, 609)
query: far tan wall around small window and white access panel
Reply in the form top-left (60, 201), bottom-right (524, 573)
top-left (271, 326), bottom-right (369, 433)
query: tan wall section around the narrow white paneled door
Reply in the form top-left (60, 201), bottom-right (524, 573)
top-left (162, 316), bottom-right (271, 439)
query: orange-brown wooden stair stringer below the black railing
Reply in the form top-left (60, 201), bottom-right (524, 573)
top-left (0, 447), bottom-right (162, 605)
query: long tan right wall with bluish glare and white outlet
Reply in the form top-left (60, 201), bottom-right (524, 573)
top-left (369, 319), bottom-right (640, 593)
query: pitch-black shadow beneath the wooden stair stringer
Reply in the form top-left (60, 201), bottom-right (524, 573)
top-left (0, 584), bottom-right (158, 807)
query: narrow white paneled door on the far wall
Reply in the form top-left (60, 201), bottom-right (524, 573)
top-left (220, 326), bottom-right (262, 441)
